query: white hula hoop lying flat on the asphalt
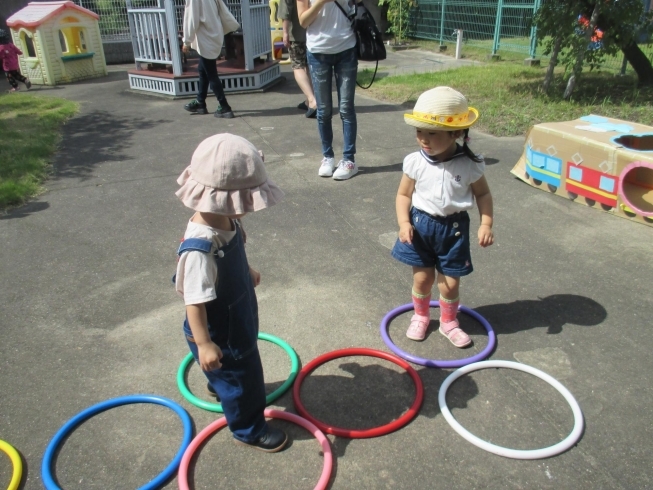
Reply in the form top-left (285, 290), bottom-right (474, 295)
top-left (438, 361), bottom-right (583, 459)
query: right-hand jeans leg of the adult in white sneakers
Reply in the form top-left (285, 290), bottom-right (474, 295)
top-left (334, 48), bottom-right (358, 162)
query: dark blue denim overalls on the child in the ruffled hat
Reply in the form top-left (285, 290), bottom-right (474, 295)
top-left (177, 226), bottom-right (267, 443)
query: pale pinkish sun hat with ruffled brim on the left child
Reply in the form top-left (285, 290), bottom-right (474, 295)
top-left (175, 133), bottom-right (284, 215)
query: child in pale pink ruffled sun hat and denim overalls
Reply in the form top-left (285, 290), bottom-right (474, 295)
top-left (175, 133), bottom-right (288, 452)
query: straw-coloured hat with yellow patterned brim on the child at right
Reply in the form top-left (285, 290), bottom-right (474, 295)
top-left (404, 87), bottom-right (478, 131)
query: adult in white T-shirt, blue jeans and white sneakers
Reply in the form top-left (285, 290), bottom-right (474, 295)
top-left (297, 0), bottom-right (358, 180)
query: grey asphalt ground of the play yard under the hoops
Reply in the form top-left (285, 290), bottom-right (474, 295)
top-left (0, 51), bottom-right (653, 490)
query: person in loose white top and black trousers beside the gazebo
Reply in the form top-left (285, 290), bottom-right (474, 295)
top-left (182, 0), bottom-right (234, 119)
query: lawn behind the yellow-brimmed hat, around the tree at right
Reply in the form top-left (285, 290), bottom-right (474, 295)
top-left (358, 62), bottom-right (653, 136)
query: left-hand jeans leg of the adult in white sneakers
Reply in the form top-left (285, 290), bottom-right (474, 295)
top-left (306, 51), bottom-right (334, 158)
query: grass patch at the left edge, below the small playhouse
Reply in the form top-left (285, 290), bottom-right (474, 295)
top-left (0, 93), bottom-right (77, 209)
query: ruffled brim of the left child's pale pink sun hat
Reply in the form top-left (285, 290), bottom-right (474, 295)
top-left (175, 167), bottom-right (284, 216)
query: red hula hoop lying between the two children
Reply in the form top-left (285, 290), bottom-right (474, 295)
top-left (292, 347), bottom-right (424, 439)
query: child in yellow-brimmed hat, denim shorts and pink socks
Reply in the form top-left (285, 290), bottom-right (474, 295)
top-left (392, 87), bottom-right (494, 347)
